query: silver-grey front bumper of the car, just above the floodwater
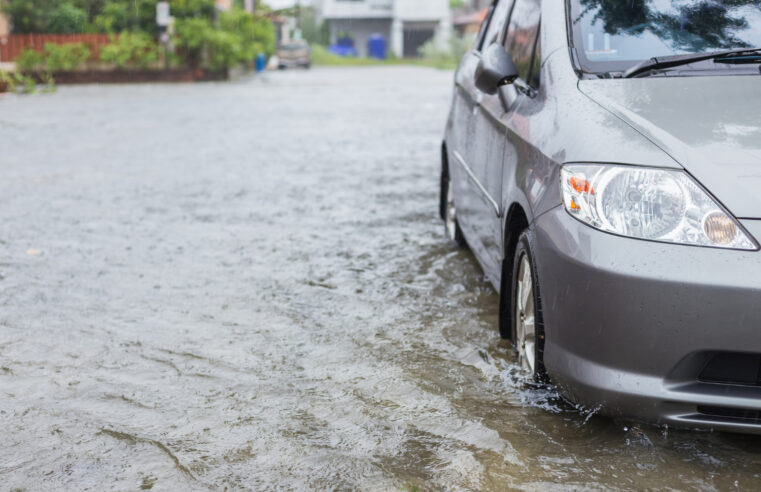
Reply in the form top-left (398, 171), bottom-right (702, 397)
top-left (532, 206), bottom-right (761, 434)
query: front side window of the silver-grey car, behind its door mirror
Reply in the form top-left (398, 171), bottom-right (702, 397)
top-left (505, 0), bottom-right (541, 82)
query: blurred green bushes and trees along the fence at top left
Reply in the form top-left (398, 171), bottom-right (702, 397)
top-left (0, 0), bottom-right (276, 90)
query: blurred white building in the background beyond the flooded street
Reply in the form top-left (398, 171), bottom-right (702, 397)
top-left (315, 0), bottom-right (452, 58)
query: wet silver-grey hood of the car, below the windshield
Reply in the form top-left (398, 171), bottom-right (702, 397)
top-left (579, 76), bottom-right (761, 218)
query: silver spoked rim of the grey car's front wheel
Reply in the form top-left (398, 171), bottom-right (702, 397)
top-left (515, 253), bottom-right (536, 374)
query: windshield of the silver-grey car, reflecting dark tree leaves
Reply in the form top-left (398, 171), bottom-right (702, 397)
top-left (571, 0), bottom-right (761, 72)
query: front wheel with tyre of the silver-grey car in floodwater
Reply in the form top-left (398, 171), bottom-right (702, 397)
top-left (510, 229), bottom-right (547, 382)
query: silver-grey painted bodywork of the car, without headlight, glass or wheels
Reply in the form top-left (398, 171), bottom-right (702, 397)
top-left (444, 0), bottom-right (761, 433)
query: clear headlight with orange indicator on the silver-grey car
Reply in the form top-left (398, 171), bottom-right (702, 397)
top-left (560, 164), bottom-right (758, 250)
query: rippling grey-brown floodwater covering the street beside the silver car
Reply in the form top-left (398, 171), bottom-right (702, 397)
top-left (0, 67), bottom-right (761, 490)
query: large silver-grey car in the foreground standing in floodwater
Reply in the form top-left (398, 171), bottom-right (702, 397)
top-left (440, 0), bottom-right (761, 433)
